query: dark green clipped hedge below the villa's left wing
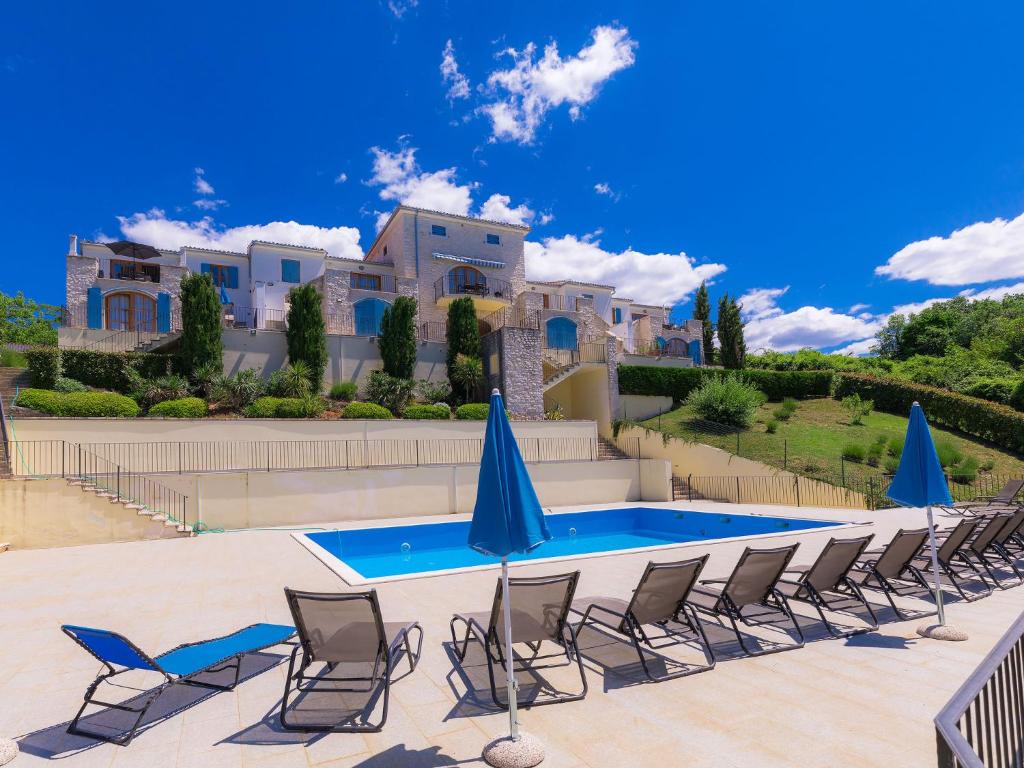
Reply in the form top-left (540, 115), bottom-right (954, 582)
top-left (27, 347), bottom-right (174, 392)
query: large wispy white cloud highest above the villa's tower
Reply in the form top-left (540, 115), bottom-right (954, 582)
top-left (479, 26), bottom-right (637, 144)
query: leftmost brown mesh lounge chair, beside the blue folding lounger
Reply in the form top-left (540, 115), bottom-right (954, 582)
top-left (281, 588), bottom-right (423, 733)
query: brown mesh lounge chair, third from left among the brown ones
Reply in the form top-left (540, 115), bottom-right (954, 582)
top-left (572, 555), bottom-right (715, 682)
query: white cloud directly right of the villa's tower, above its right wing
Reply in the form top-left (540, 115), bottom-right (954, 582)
top-left (524, 234), bottom-right (725, 305)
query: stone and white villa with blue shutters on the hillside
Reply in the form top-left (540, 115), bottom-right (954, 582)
top-left (60, 206), bottom-right (703, 423)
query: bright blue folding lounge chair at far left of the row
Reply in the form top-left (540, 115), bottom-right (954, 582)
top-left (60, 624), bottom-right (295, 746)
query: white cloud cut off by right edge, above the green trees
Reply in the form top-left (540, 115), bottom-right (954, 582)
top-left (874, 208), bottom-right (1024, 286)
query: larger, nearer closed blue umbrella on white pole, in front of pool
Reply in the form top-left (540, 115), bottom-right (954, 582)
top-left (468, 389), bottom-right (551, 741)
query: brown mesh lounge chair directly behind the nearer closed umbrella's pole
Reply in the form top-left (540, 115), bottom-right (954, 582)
top-left (450, 570), bottom-right (587, 708)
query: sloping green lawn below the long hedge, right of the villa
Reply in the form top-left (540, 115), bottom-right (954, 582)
top-left (643, 398), bottom-right (1024, 478)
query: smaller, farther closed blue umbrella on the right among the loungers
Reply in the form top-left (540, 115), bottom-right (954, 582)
top-left (886, 402), bottom-right (952, 626)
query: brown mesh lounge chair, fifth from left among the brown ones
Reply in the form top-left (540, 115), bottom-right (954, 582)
top-left (778, 534), bottom-right (879, 638)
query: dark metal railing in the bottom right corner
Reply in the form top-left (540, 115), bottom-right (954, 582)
top-left (935, 613), bottom-right (1024, 768)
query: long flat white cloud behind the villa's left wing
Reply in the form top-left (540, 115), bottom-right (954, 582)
top-left (118, 208), bottom-right (362, 259)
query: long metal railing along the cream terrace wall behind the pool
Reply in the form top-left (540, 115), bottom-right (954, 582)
top-left (7, 437), bottom-right (640, 477)
